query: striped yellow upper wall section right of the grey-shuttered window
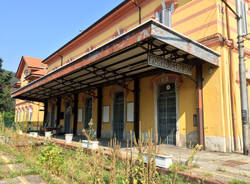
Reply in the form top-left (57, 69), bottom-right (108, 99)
top-left (172, 0), bottom-right (218, 40)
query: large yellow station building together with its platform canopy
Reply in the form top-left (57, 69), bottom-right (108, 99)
top-left (12, 0), bottom-right (250, 152)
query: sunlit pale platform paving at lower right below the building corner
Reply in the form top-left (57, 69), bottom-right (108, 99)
top-left (119, 144), bottom-right (250, 183)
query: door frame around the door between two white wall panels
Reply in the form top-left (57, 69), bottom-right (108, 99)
top-left (110, 90), bottom-right (126, 140)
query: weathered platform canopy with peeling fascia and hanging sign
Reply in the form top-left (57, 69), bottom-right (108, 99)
top-left (12, 20), bottom-right (219, 101)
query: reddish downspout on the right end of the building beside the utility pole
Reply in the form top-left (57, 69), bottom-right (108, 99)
top-left (226, 0), bottom-right (237, 151)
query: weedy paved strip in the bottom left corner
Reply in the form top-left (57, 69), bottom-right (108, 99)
top-left (0, 152), bottom-right (46, 184)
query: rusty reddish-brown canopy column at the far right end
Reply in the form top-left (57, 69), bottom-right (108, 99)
top-left (196, 64), bottom-right (205, 149)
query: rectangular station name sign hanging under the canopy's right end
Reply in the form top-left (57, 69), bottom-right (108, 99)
top-left (148, 54), bottom-right (192, 75)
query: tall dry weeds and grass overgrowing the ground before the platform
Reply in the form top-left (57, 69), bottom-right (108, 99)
top-left (0, 125), bottom-right (246, 184)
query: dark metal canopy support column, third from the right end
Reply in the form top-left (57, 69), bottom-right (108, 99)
top-left (97, 87), bottom-right (102, 138)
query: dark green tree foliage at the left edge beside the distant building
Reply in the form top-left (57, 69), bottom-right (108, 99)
top-left (0, 58), bottom-right (15, 121)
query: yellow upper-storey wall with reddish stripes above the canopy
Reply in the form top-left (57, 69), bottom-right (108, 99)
top-left (48, 0), bottom-right (224, 71)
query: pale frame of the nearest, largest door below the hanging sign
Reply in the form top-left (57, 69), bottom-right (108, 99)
top-left (153, 79), bottom-right (180, 146)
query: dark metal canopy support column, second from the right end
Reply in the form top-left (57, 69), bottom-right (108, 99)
top-left (134, 78), bottom-right (140, 140)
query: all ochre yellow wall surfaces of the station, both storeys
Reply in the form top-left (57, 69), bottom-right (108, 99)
top-left (15, 0), bottom-right (250, 151)
